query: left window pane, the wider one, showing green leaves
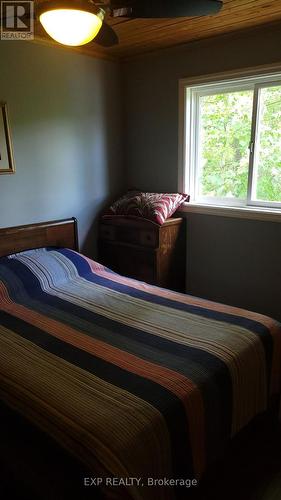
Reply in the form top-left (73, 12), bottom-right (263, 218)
top-left (198, 90), bottom-right (253, 200)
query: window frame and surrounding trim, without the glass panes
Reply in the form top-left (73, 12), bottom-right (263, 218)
top-left (179, 65), bottom-right (281, 213)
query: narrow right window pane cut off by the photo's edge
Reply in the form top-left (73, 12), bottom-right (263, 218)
top-left (254, 86), bottom-right (281, 202)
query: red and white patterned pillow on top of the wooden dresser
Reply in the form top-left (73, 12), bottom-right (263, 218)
top-left (103, 191), bottom-right (189, 225)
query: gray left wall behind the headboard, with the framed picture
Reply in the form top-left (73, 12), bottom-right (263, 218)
top-left (0, 41), bottom-right (124, 254)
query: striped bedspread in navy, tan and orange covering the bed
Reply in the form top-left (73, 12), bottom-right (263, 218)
top-left (0, 249), bottom-right (281, 500)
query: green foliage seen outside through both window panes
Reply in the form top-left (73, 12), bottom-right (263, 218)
top-left (200, 86), bottom-right (281, 201)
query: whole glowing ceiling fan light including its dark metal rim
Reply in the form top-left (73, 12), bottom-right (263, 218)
top-left (37, 0), bottom-right (105, 46)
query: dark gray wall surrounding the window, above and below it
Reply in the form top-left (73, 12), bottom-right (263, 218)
top-left (126, 26), bottom-right (281, 320)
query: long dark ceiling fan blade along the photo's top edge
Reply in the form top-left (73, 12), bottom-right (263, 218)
top-left (111, 0), bottom-right (223, 18)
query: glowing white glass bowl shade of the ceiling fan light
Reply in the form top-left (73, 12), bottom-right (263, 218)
top-left (39, 8), bottom-right (103, 46)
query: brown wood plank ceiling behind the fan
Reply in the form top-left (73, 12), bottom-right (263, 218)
top-left (35, 0), bottom-right (281, 60)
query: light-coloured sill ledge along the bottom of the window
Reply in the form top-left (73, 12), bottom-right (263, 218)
top-left (179, 203), bottom-right (281, 222)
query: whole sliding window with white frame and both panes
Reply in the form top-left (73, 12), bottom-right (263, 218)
top-left (179, 74), bottom-right (281, 208)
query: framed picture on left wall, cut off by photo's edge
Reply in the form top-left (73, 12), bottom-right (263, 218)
top-left (0, 102), bottom-right (15, 174)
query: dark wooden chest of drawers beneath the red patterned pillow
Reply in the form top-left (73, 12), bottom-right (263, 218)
top-left (98, 217), bottom-right (186, 292)
